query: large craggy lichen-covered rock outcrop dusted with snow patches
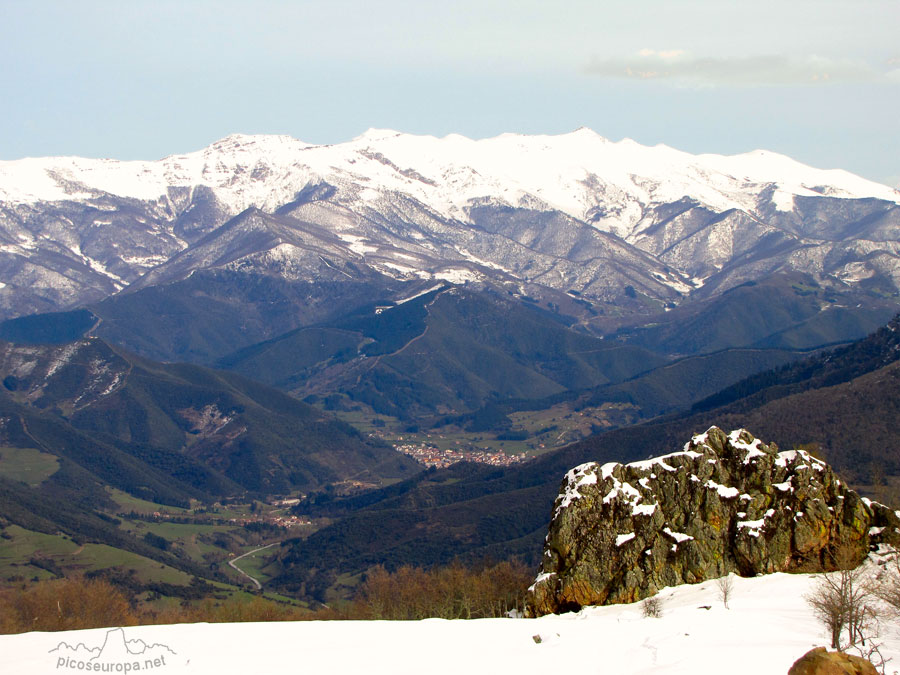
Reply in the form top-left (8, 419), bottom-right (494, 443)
top-left (529, 427), bottom-right (900, 615)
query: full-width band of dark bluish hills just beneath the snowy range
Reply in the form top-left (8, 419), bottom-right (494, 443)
top-left (0, 267), bottom-right (884, 438)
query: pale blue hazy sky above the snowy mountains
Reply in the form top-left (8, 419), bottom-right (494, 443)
top-left (0, 0), bottom-right (900, 186)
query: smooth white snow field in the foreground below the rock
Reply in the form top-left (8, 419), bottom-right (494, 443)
top-left (0, 574), bottom-right (900, 675)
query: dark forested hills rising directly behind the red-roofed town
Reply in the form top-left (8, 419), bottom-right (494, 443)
top-left (217, 275), bottom-right (896, 424)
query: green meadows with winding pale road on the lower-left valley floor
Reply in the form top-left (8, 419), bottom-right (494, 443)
top-left (0, 476), bottom-right (322, 609)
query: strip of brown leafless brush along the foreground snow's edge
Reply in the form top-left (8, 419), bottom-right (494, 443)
top-left (0, 562), bottom-right (533, 634)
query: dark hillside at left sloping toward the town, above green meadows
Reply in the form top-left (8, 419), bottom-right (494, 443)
top-left (0, 339), bottom-right (418, 492)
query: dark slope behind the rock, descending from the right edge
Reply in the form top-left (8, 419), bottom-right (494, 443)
top-left (281, 314), bottom-right (900, 600)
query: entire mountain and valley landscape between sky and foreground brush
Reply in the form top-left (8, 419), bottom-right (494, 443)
top-left (0, 130), bottom-right (900, 624)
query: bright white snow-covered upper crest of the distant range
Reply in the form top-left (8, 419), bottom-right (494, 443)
top-left (0, 127), bottom-right (900, 219)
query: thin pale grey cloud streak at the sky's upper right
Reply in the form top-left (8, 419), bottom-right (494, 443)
top-left (587, 49), bottom-right (900, 86)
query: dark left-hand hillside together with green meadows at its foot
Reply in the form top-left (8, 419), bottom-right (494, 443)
top-left (0, 338), bottom-right (422, 598)
